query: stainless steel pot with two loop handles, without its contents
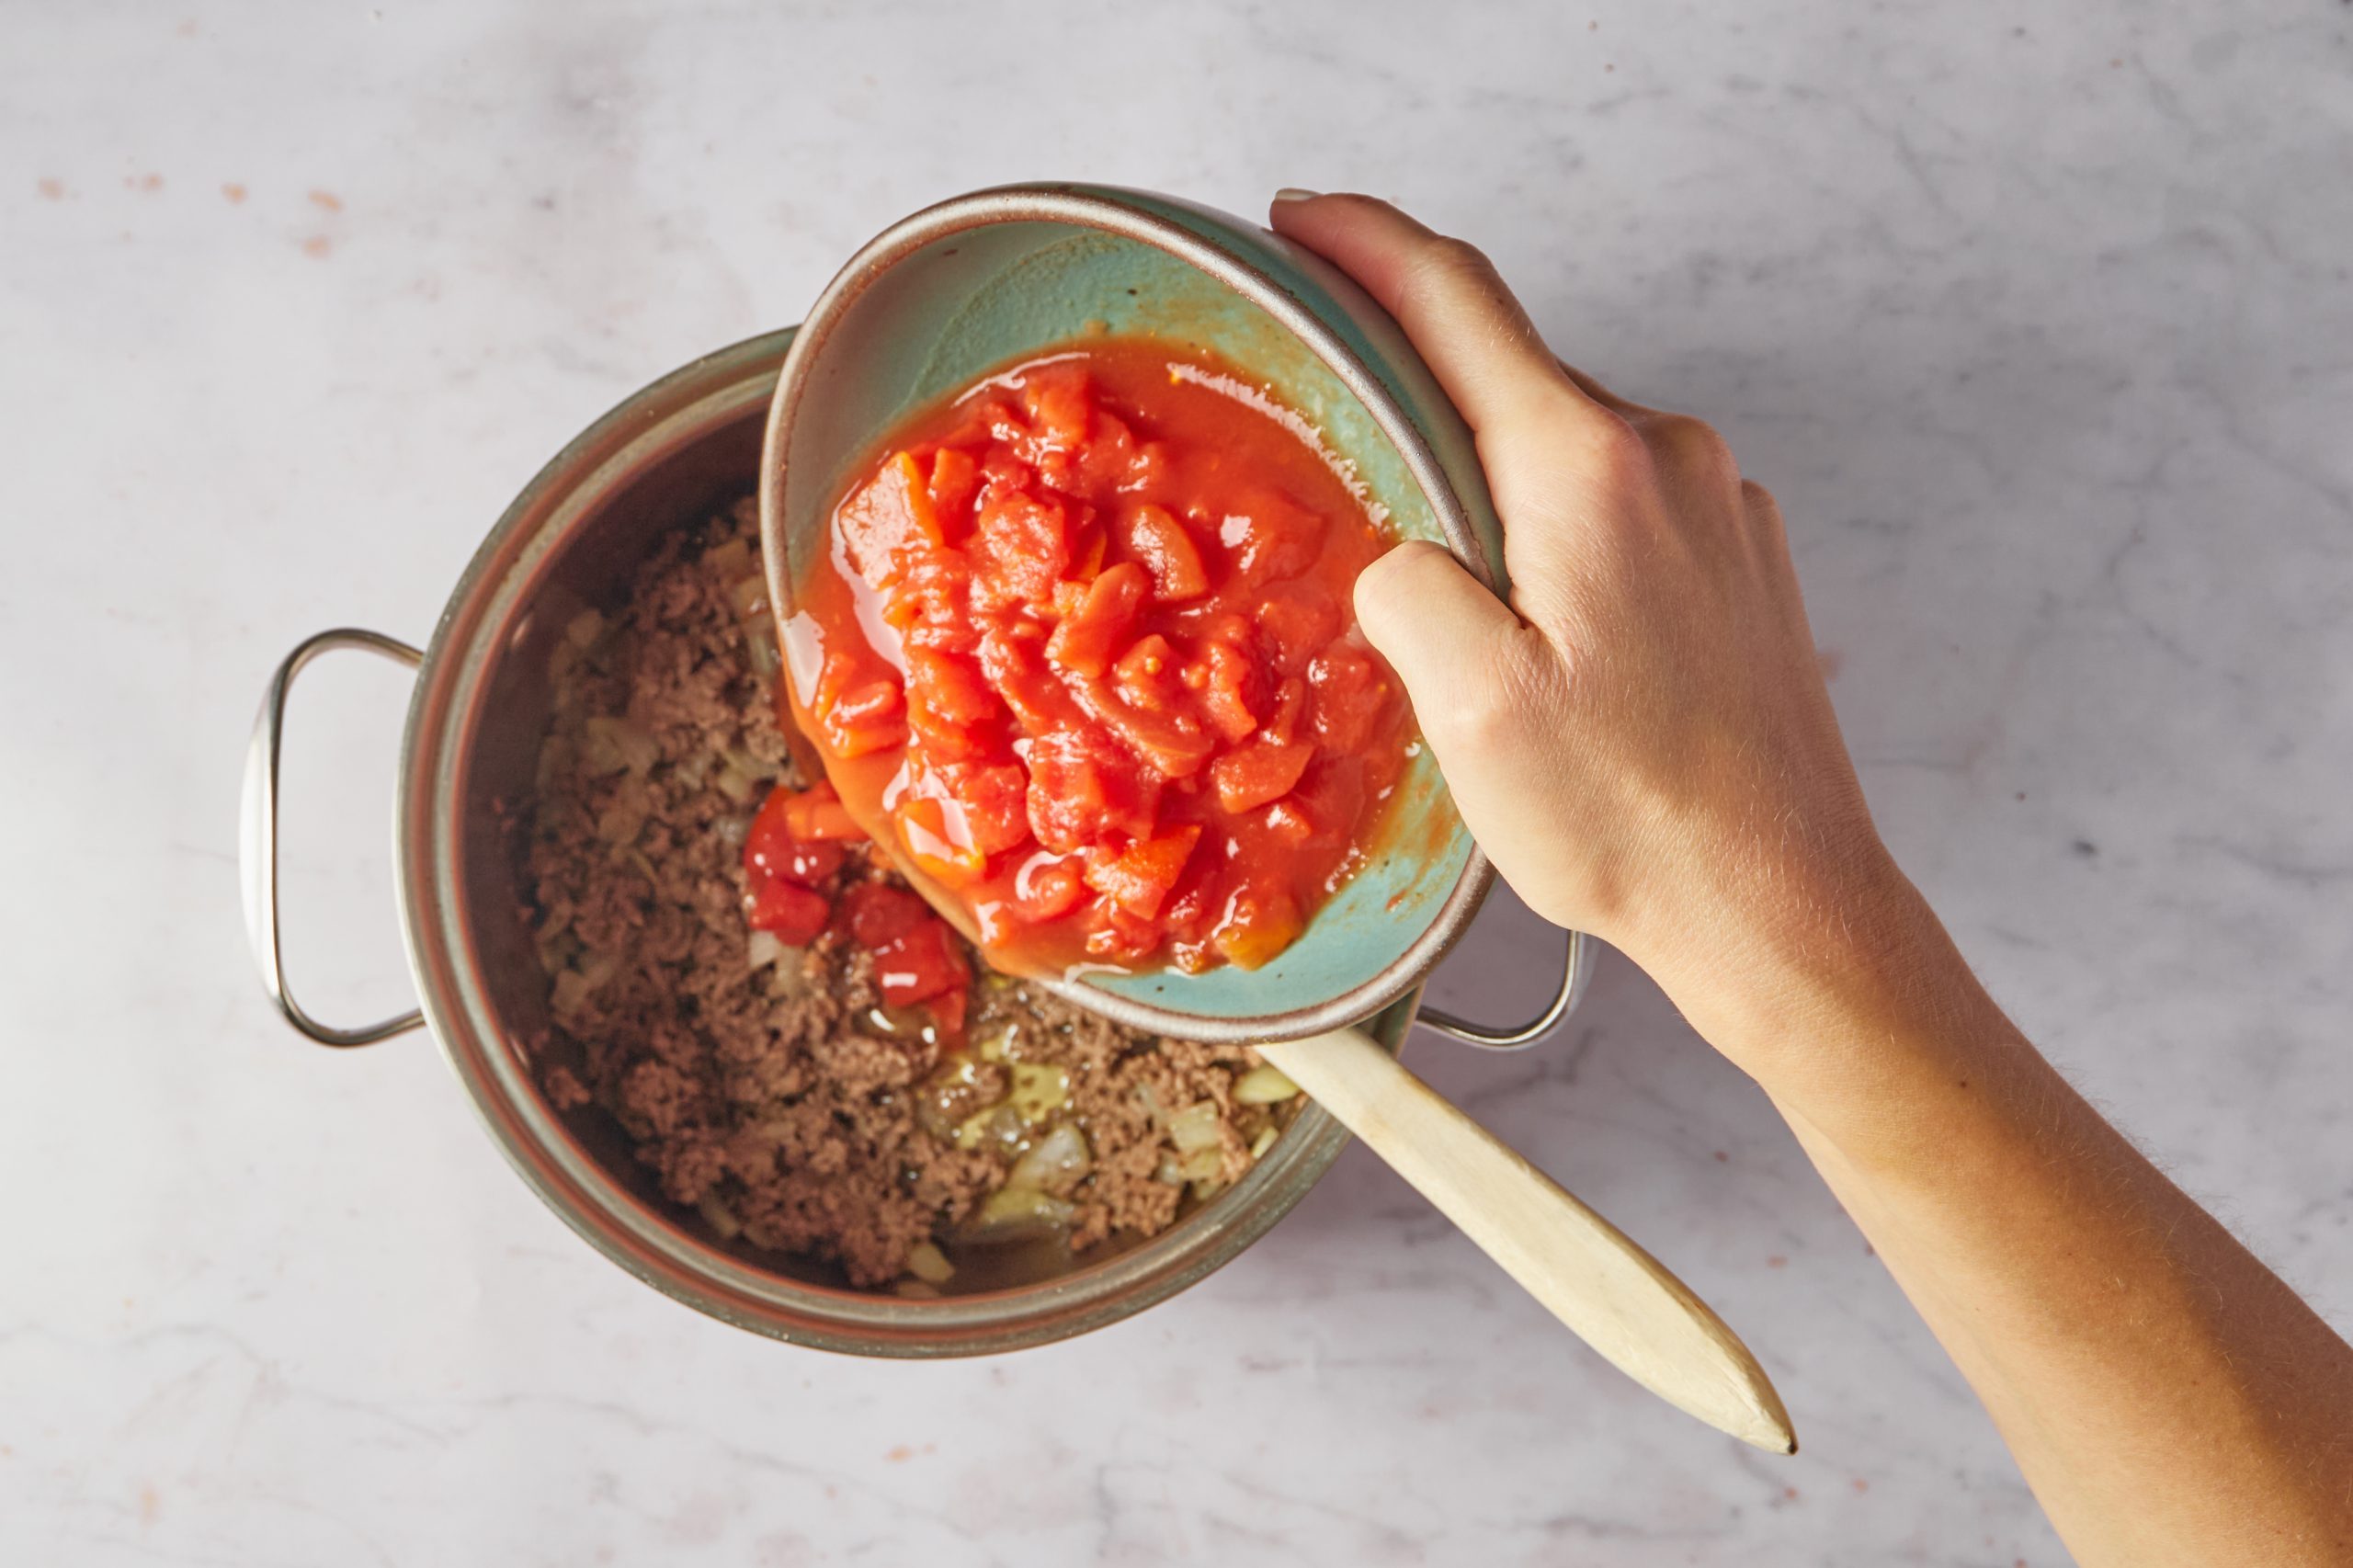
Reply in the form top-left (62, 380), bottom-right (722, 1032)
top-left (243, 330), bottom-right (1588, 1356)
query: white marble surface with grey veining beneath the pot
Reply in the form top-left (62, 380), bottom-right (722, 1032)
top-left (0, 0), bottom-right (2353, 1568)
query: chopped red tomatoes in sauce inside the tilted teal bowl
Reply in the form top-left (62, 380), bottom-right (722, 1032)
top-left (783, 336), bottom-right (1415, 974)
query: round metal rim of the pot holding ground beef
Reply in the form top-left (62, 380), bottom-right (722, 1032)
top-left (393, 327), bottom-right (1419, 1358)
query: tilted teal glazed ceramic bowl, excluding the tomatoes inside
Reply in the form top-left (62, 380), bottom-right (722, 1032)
top-left (760, 184), bottom-right (1506, 1040)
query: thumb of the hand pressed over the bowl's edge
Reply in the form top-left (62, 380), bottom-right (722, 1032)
top-left (1356, 540), bottom-right (1534, 715)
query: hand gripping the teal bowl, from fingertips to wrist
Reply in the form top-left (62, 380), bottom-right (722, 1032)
top-left (1273, 196), bottom-right (1908, 1022)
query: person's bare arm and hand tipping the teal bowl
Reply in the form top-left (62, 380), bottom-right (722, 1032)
top-left (1276, 198), bottom-right (2353, 1565)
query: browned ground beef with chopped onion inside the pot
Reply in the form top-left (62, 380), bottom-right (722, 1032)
top-left (529, 499), bottom-right (1291, 1295)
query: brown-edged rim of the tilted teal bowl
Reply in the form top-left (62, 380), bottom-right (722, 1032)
top-left (757, 181), bottom-right (1501, 1045)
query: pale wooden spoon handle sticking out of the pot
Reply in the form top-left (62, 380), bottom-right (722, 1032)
top-left (1259, 1028), bottom-right (1798, 1452)
